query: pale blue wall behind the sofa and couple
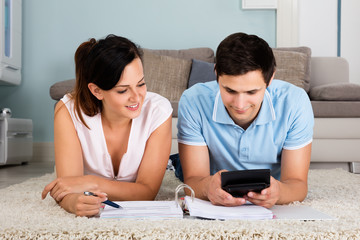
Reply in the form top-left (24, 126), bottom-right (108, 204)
top-left (0, 0), bottom-right (276, 142)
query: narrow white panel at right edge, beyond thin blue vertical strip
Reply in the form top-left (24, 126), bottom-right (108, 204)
top-left (341, 0), bottom-right (360, 84)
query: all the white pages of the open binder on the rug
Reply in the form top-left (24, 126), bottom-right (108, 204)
top-left (100, 196), bottom-right (336, 220)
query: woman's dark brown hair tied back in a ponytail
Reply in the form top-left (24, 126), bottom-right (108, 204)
top-left (72, 34), bottom-right (142, 127)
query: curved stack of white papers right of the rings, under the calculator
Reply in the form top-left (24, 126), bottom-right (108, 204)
top-left (185, 196), bottom-right (273, 220)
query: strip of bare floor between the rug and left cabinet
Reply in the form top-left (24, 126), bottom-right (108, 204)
top-left (0, 161), bottom-right (55, 189)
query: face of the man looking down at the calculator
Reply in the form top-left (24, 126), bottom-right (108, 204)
top-left (219, 70), bottom-right (267, 129)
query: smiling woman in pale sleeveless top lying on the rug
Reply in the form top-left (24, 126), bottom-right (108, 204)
top-left (42, 35), bottom-right (172, 216)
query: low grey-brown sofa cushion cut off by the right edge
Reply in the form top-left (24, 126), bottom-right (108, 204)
top-left (309, 83), bottom-right (360, 101)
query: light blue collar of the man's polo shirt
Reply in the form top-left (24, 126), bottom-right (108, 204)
top-left (212, 89), bottom-right (276, 125)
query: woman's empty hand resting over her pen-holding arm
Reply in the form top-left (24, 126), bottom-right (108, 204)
top-left (41, 175), bottom-right (98, 202)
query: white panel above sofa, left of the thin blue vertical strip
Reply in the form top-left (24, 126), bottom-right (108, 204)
top-left (298, 0), bottom-right (338, 57)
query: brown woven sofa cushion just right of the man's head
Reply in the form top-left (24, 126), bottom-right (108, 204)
top-left (273, 47), bottom-right (311, 92)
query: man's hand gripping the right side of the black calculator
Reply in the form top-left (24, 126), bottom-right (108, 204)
top-left (245, 177), bottom-right (280, 208)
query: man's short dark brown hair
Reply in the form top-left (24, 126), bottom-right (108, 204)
top-left (215, 33), bottom-right (276, 85)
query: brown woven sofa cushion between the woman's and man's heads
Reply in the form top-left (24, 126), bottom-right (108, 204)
top-left (142, 49), bottom-right (191, 101)
